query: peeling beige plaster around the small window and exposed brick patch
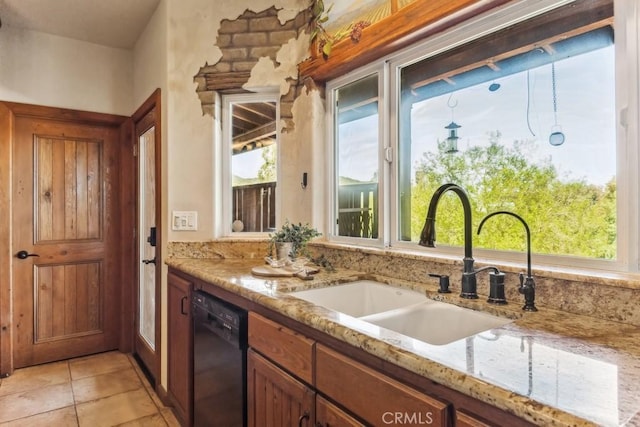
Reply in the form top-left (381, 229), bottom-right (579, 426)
top-left (166, 0), bottom-right (324, 241)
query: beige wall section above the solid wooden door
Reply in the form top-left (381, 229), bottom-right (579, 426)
top-left (0, 27), bottom-right (133, 115)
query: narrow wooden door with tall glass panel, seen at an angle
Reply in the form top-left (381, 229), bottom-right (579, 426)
top-left (132, 89), bottom-right (162, 386)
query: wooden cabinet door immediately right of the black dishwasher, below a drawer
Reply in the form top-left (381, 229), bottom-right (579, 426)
top-left (247, 349), bottom-right (315, 427)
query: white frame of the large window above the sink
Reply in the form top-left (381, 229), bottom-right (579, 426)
top-left (327, 0), bottom-right (640, 272)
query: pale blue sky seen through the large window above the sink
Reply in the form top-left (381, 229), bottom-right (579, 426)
top-left (340, 47), bottom-right (616, 185)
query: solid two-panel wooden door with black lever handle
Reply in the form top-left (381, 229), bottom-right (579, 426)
top-left (11, 110), bottom-right (121, 368)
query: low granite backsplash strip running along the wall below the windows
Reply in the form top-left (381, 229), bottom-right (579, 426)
top-left (167, 239), bottom-right (640, 326)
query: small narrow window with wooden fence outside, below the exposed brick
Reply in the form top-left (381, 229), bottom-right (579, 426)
top-left (222, 94), bottom-right (279, 235)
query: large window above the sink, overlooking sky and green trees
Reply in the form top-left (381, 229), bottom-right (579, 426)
top-left (327, 0), bottom-right (637, 269)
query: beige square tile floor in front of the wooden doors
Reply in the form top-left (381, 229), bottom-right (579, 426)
top-left (0, 351), bottom-right (179, 427)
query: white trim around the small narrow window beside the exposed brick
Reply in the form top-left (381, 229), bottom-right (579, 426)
top-left (220, 88), bottom-right (282, 238)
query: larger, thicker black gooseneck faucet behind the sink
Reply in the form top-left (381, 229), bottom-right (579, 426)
top-left (418, 183), bottom-right (478, 299)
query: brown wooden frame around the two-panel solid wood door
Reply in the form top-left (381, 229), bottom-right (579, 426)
top-left (0, 101), bottom-right (134, 377)
